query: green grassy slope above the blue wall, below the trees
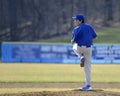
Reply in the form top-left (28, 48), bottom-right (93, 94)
top-left (42, 27), bottom-right (120, 44)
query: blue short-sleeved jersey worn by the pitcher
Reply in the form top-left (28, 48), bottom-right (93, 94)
top-left (72, 23), bottom-right (97, 46)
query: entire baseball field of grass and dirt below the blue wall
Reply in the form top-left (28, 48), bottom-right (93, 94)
top-left (0, 63), bottom-right (120, 96)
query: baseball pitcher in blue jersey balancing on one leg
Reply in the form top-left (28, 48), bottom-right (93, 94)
top-left (71, 14), bottom-right (97, 91)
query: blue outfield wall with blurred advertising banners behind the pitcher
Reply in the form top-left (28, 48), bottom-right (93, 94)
top-left (2, 43), bottom-right (120, 64)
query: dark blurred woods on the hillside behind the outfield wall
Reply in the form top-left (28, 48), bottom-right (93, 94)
top-left (0, 0), bottom-right (120, 41)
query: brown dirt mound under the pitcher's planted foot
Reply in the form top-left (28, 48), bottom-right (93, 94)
top-left (0, 90), bottom-right (120, 96)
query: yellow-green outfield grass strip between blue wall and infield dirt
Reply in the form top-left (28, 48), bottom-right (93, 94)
top-left (0, 63), bottom-right (120, 82)
